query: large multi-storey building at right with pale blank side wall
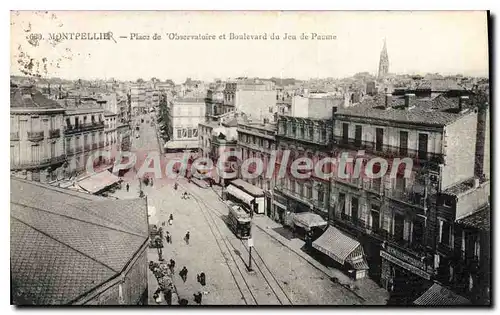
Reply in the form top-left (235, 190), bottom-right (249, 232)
top-left (330, 90), bottom-right (486, 302)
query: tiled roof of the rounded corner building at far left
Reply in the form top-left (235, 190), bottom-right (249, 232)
top-left (10, 87), bottom-right (62, 109)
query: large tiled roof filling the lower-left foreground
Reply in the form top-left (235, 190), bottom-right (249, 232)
top-left (11, 178), bottom-right (148, 305)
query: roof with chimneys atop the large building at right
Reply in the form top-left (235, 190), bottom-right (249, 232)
top-left (335, 95), bottom-right (470, 126)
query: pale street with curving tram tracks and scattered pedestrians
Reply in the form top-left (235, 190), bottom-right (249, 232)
top-left (115, 115), bottom-right (363, 305)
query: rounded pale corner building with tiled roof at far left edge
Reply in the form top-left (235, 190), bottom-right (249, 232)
top-left (10, 85), bottom-right (66, 182)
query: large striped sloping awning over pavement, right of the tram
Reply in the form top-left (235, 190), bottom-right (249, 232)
top-left (313, 226), bottom-right (365, 269)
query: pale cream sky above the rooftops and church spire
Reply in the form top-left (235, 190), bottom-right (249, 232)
top-left (11, 11), bottom-right (488, 82)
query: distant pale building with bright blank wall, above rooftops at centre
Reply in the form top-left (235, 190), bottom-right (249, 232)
top-left (223, 79), bottom-right (277, 121)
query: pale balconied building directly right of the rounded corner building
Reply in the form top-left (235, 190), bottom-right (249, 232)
top-left (64, 105), bottom-right (105, 177)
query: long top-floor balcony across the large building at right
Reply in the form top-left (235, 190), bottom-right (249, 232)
top-left (333, 136), bottom-right (444, 165)
